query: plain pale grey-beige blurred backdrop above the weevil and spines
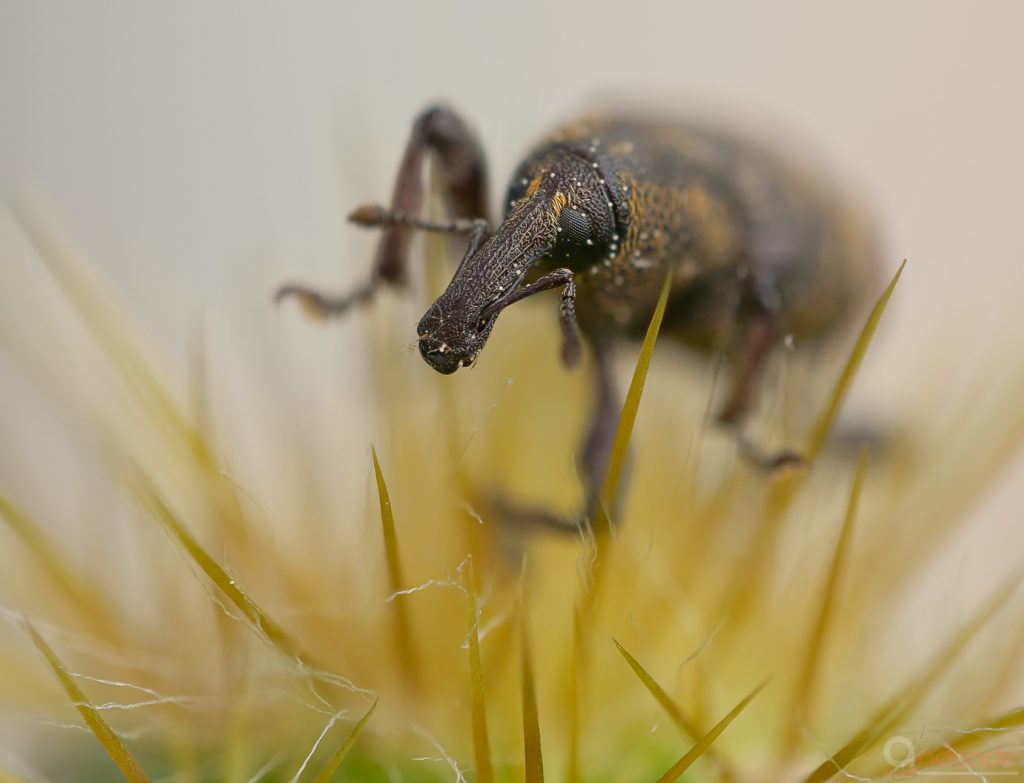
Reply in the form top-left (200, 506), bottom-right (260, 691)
top-left (0, 0), bottom-right (1024, 544)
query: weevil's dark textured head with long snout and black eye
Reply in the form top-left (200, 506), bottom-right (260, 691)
top-left (417, 150), bottom-right (614, 375)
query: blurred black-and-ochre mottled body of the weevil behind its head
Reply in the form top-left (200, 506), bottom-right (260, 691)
top-left (506, 117), bottom-right (872, 349)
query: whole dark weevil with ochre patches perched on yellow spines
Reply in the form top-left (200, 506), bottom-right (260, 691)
top-left (278, 100), bottom-right (873, 522)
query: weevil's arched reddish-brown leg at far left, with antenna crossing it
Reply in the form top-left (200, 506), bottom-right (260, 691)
top-left (274, 106), bottom-right (487, 317)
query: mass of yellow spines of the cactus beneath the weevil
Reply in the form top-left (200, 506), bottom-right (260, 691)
top-left (0, 208), bottom-right (1024, 783)
